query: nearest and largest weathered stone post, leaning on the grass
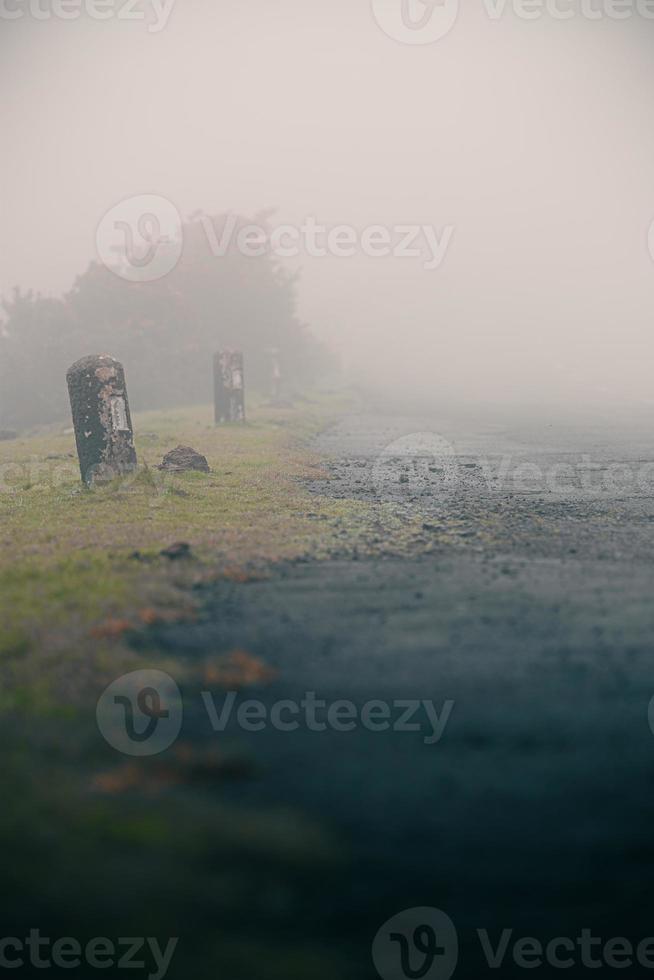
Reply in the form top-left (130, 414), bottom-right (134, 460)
top-left (66, 354), bottom-right (136, 485)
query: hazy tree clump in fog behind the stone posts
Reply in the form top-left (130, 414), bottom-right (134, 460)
top-left (0, 214), bottom-right (332, 427)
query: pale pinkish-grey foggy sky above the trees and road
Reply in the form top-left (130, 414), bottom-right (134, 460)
top-left (0, 0), bottom-right (654, 404)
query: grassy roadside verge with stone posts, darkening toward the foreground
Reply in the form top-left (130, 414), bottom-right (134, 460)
top-left (0, 394), bottom-right (368, 980)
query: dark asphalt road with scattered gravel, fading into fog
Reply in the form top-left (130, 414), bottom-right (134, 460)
top-left (145, 415), bottom-right (654, 980)
